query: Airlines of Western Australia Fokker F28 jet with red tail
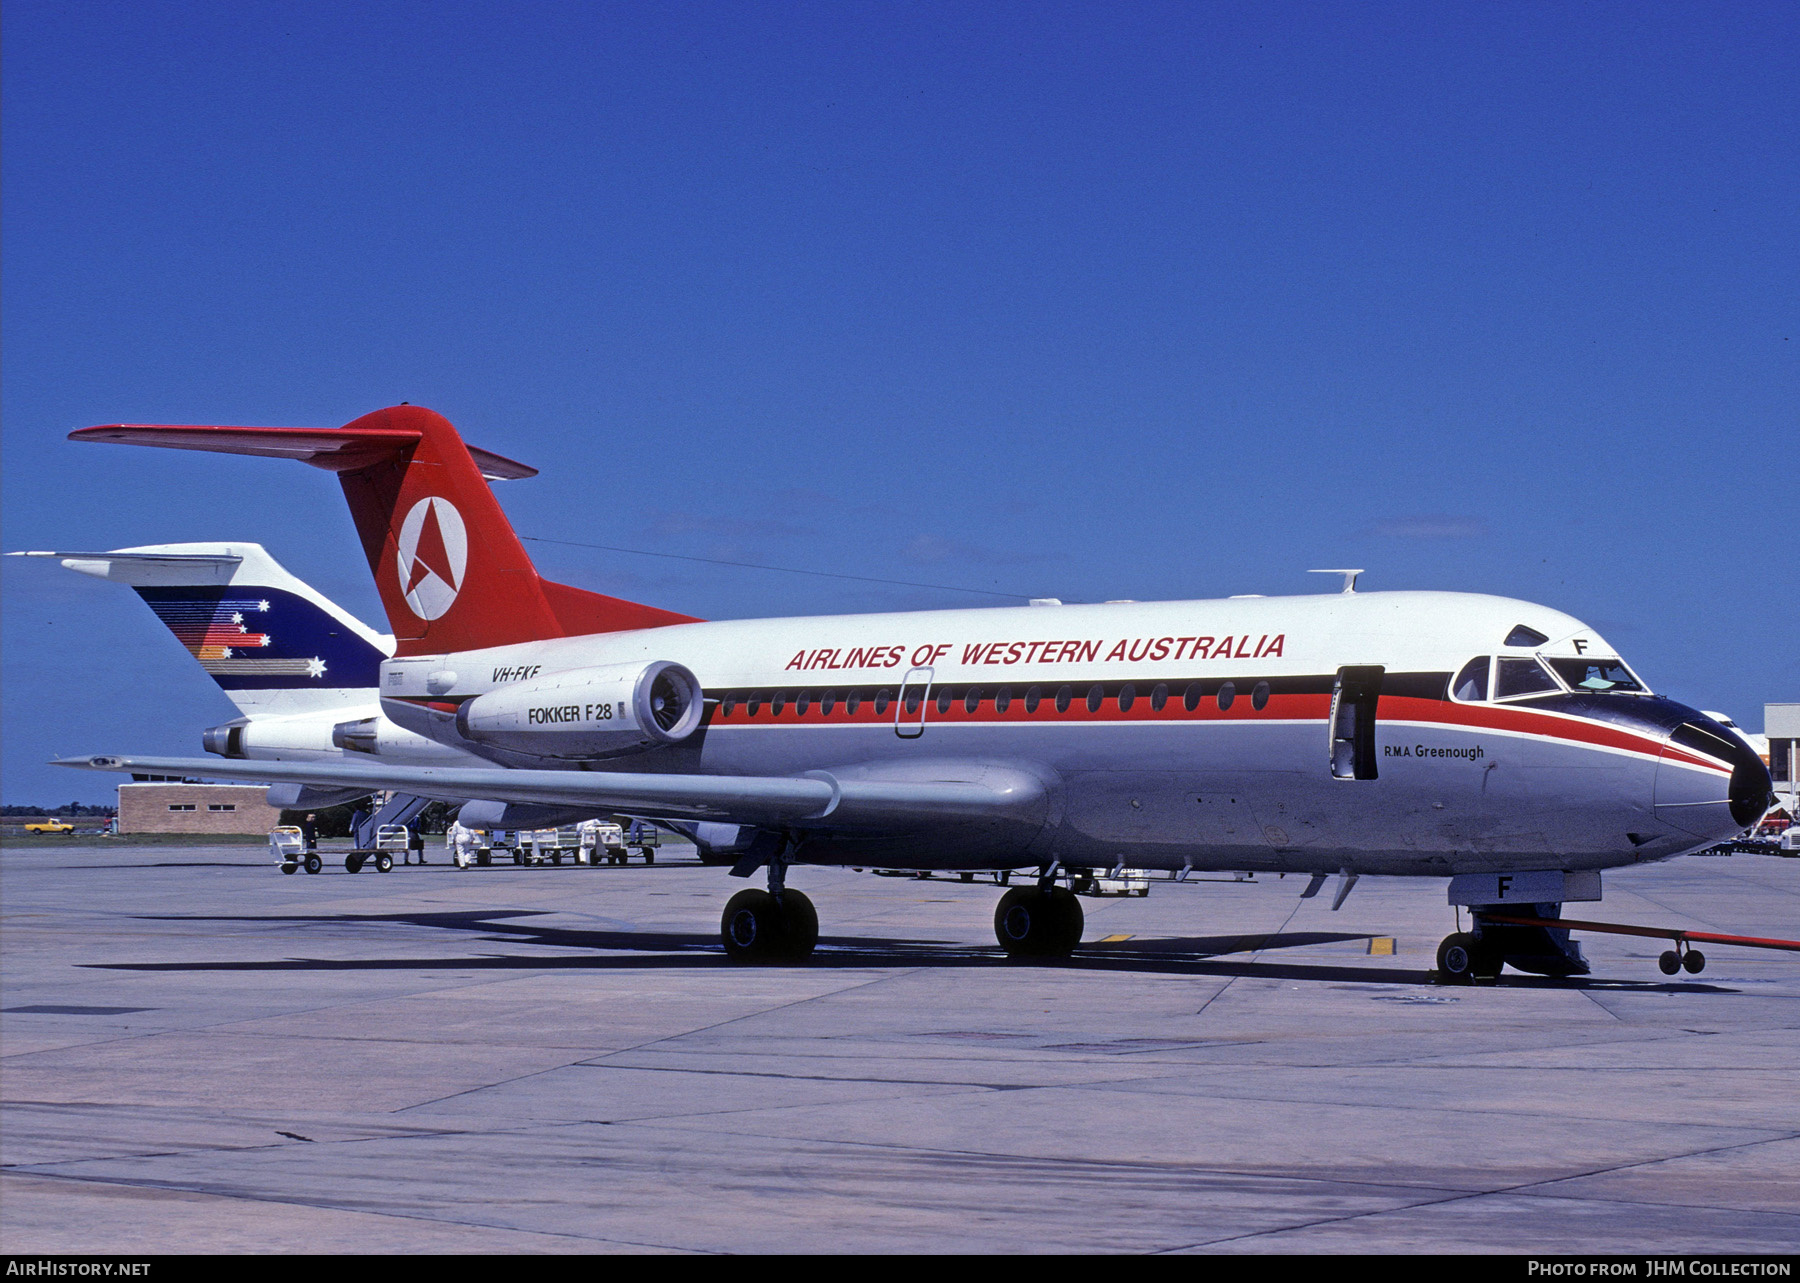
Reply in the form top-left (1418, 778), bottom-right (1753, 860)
top-left (68, 405), bottom-right (1769, 979)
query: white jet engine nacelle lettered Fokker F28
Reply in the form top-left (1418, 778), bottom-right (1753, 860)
top-left (455, 660), bottom-right (702, 758)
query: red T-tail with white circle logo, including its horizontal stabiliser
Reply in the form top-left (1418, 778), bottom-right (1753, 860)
top-left (70, 405), bottom-right (693, 655)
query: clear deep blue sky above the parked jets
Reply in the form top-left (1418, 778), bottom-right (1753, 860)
top-left (0, 0), bottom-right (1800, 803)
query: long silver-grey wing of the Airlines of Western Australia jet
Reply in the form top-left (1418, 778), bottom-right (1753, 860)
top-left (56, 756), bottom-right (1044, 830)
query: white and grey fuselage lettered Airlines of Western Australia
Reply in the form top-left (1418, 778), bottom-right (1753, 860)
top-left (382, 592), bottom-right (1739, 876)
